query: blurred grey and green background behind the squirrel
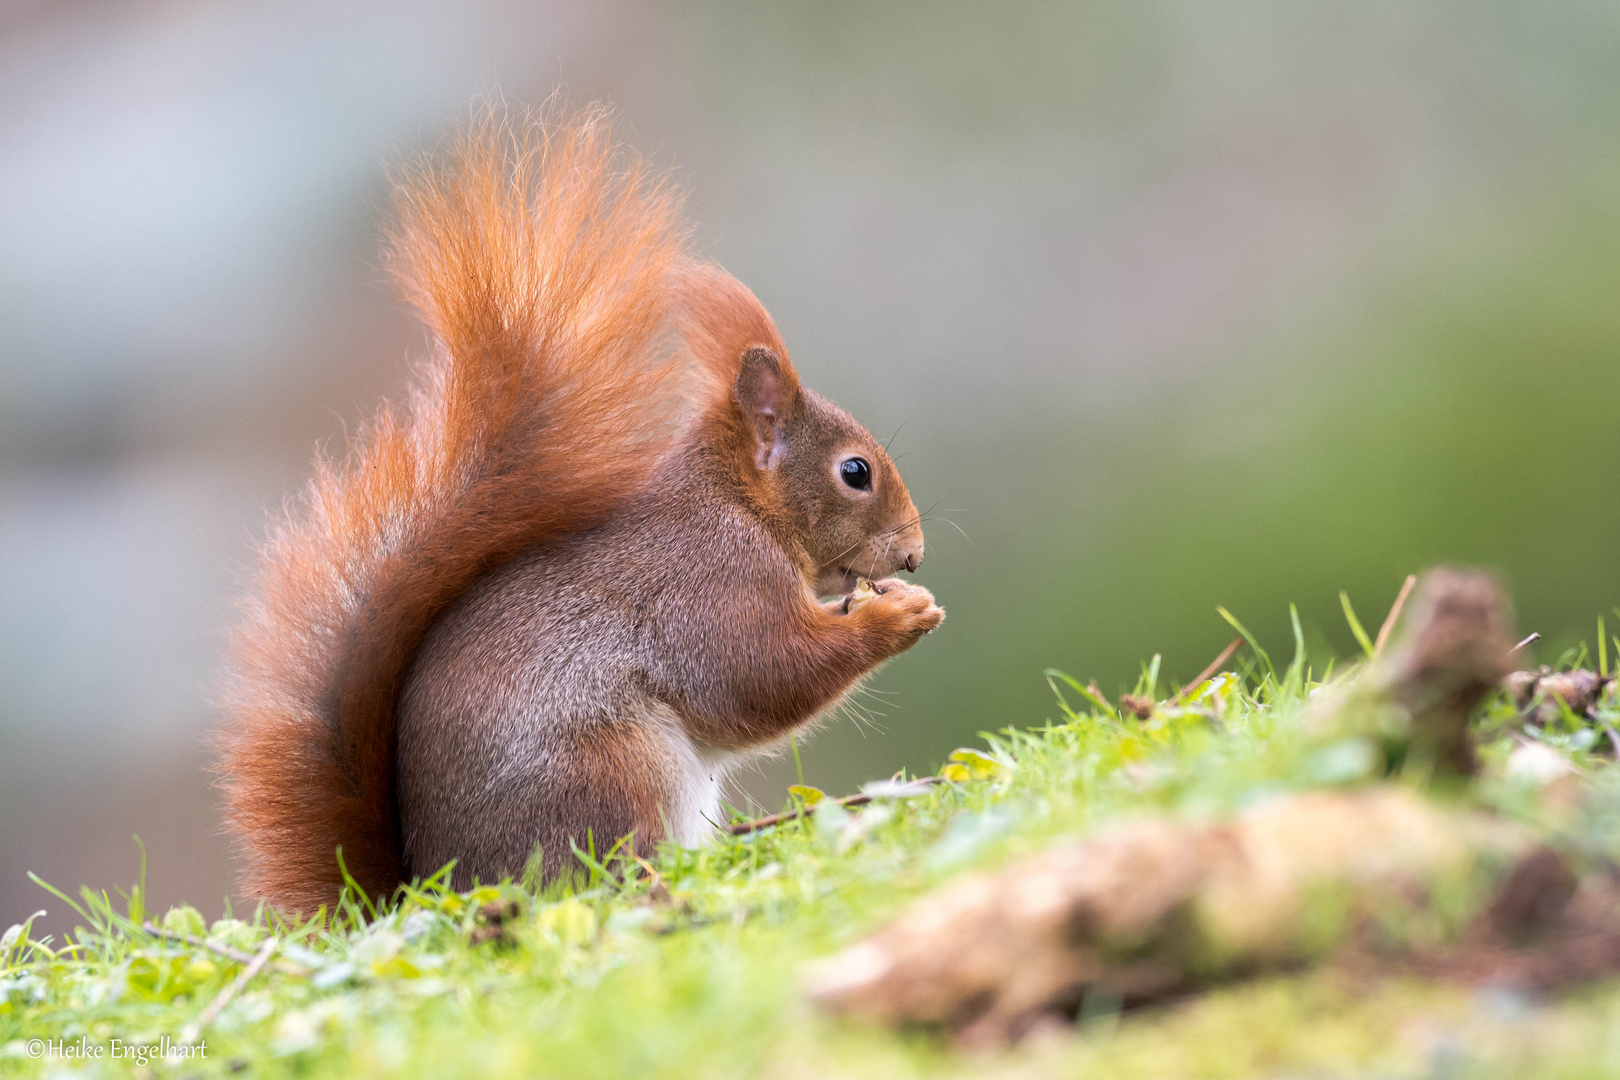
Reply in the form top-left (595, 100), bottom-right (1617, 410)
top-left (0, 0), bottom-right (1620, 928)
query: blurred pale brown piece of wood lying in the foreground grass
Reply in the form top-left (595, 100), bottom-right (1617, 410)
top-left (808, 785), bottom-right (1561, 1046)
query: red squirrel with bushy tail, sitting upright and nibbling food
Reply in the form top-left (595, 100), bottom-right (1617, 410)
top-left (220, 110), bottom-right (944, 913)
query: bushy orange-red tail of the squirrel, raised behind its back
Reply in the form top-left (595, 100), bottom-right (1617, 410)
top-left (220, 108), bottom-right (685, 913)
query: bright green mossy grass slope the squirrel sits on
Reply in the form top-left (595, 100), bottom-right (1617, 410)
top-left (0, 623), bottom-right (1620, 1078)
